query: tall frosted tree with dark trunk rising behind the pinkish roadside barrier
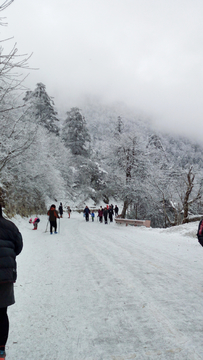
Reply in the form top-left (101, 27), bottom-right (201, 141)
top-left (108, 120), bottom-right (146, 217)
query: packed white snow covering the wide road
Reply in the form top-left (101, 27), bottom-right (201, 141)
top-left (4, 212), bottom-right (203, 360)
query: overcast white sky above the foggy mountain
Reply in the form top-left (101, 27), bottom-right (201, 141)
top-left (0, 0), bottom-right (203, 139)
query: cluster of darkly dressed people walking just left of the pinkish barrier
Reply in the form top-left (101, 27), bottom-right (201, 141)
top-left (83, 204), bottom-right (119, 224)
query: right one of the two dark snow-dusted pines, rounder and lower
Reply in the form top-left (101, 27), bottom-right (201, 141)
top-left (62, 107), bottom-right (90, 157)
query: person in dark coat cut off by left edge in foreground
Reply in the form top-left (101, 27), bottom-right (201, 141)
top-left (0, 205), bottom-right (23, 358)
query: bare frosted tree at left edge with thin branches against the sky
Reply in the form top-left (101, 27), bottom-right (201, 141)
top-left (0, 0), bottom-right (35, 176)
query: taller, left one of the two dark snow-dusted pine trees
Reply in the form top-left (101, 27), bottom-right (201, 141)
top-left (23, 83), bottom-right (59, 135)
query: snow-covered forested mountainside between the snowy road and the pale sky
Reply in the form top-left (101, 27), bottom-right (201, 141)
top-left (0, 1), bottom-right (203, 227)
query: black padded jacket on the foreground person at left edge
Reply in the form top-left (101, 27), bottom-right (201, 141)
top-left (0, 217), bottom-right (23, 283)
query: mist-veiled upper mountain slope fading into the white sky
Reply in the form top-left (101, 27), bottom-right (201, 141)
top-left (78, 102), bottom-right (203, 168)
